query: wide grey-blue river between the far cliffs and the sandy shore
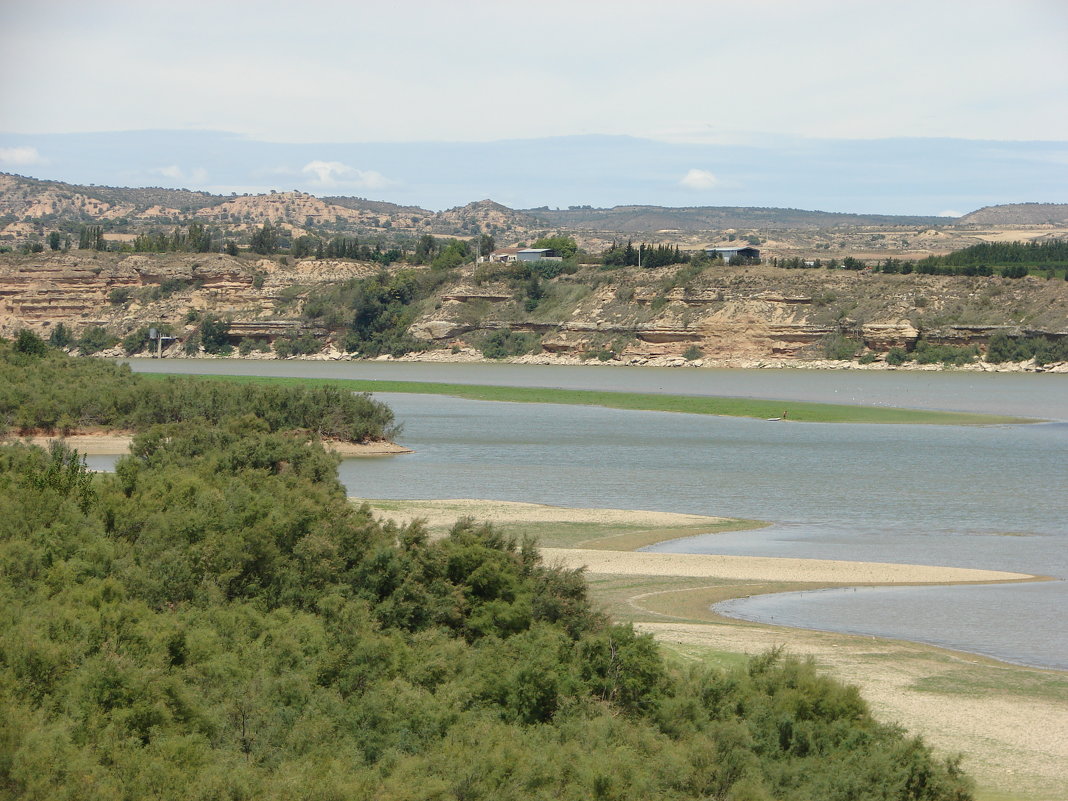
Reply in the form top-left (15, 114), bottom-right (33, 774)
top-left (130, 359), bottom-right (1068, 670)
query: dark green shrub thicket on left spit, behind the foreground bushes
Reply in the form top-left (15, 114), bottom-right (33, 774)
top-left (0, 345), bottom-right (396, 442)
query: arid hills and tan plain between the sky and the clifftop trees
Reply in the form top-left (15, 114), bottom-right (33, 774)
top-left (8, 173), bottom-right (1068, 260)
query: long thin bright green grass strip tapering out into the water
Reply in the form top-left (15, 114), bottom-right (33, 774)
top-left (140, 373), bottom-right (1039, 425)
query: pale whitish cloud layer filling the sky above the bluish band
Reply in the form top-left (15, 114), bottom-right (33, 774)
top-left (0, 0), bottom-right (1068, 142)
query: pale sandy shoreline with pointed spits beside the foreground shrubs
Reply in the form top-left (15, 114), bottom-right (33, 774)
top-left (354, 499), bottom-right (1068, 801)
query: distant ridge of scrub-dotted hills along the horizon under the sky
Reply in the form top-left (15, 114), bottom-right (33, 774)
top-left (0, 173), bottom-right (1050, 240)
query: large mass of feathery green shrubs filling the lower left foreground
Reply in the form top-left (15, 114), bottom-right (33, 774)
top-left (0, 355), bottom-right (971, 801)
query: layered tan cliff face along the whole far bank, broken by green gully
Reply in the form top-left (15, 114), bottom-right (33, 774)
top-left (0, 251), bottom-right (1068, 360)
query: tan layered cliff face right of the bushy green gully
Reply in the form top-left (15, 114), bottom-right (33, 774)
top-left (412, 266), bottom-right (1068, 361)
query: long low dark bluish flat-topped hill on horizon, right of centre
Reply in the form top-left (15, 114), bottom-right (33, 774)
top-left (525, 206), bottom-right (947, 234)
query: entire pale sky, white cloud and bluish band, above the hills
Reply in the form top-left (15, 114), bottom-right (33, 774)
top-left (0, 0), bottom-right (1068, 214)
